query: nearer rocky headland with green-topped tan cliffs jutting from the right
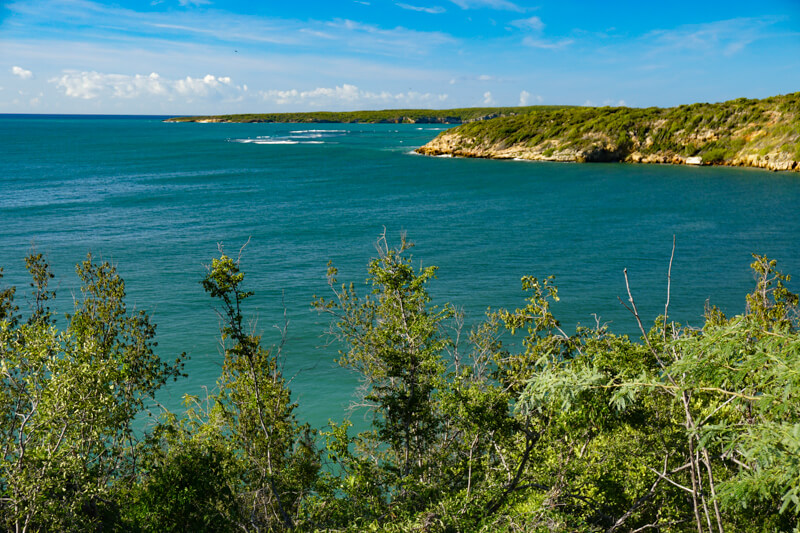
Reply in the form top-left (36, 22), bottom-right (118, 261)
top-left (416, 93), bottom-right (800, 171)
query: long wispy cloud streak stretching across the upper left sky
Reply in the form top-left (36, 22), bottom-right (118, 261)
top-left (8, 0), bottom-right (455, 56)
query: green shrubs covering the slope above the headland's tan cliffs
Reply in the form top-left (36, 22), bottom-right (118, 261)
top-left (447, 93), bottom-right (800, 163)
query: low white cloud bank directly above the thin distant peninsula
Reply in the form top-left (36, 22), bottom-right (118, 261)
top-left (259, 83), bottom-right (448, 109)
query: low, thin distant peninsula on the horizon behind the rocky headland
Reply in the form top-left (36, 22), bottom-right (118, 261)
top-left (164, 106), bottom-right (566, 124)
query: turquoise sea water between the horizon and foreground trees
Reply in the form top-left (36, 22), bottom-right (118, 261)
top-left (0, 116), bottom-right (800, 426)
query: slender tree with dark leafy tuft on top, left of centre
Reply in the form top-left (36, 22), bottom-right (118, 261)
top-left (194, 244), bottom-right (319, 530)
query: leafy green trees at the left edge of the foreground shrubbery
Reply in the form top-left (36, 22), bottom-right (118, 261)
top-left (0, 254), bottom-right (182, 531)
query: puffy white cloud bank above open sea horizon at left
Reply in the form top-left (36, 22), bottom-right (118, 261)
top-left (48, 71), bottom-right (242, 100)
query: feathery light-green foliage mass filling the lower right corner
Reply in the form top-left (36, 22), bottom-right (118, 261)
top-left (518, 251), bottom-right (800, 533)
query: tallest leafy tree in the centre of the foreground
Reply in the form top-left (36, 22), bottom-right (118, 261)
top-left (314, 235), bottom-right (453, 512)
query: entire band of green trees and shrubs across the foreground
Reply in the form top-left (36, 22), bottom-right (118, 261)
top-left (0, 238), bottom-right (800, 533)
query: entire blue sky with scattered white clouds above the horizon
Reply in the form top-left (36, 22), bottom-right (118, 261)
top-left (0, 0), bottom-right (800, 115)
